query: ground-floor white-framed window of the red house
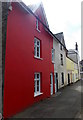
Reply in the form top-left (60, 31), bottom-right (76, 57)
top-left (34, 73), bottom-right (40, 95)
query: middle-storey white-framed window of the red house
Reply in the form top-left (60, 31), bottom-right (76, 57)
top-left (34, 38), bottom-right (40, 58)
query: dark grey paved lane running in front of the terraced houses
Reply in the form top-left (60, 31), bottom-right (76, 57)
top-left (12, 80), bottom-right (83, 118)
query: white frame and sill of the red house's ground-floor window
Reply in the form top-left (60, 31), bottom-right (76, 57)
top-left (34, 73), bottom-right (40, 96)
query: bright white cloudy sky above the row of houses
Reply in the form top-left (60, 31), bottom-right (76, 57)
top-left (22, 0), bottom-right (82, 60)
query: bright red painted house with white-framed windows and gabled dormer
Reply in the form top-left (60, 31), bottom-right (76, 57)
top-left (3, 2), bottom-right (55, 118)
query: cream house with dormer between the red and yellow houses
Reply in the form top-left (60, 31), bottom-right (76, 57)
top-left (53, 32), bottom-right (67, 92)
